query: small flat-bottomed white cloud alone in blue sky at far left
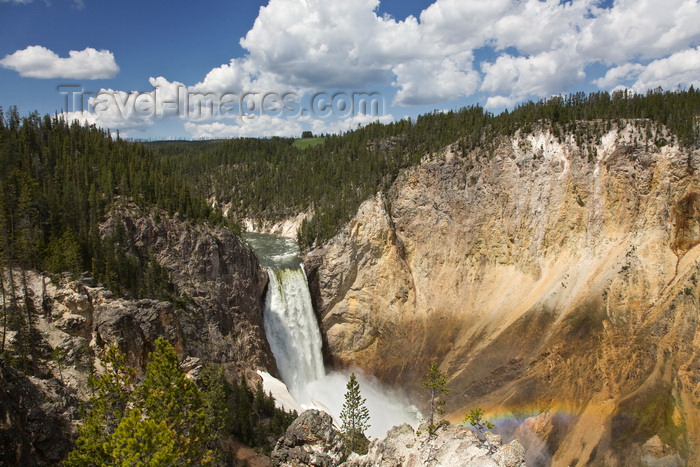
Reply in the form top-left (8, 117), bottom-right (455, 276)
top-left (0, 45), bottom-right (119, 79)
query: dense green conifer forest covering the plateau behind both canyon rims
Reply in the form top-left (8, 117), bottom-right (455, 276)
top-left (0, 87), bottom-right (700, 370)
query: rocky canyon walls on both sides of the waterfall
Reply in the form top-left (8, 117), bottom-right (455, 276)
top-left (0, 120), bottom-right (700, 466)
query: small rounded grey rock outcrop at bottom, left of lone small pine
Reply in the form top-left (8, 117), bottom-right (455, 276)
top-left (272, 410), bottom-right (346, 467)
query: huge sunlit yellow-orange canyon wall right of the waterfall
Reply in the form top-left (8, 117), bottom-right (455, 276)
top-left (306, 125), bottom-right (700, 465)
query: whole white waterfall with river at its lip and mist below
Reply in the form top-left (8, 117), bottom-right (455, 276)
top-left (244, 233), bottom-right (421, 437)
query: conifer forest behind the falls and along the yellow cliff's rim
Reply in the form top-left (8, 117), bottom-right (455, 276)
top-left (146, 87), bottom-right (700, 247)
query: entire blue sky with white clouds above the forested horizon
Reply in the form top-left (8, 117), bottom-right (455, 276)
top-left (0, 0), bottom-right (700, 139)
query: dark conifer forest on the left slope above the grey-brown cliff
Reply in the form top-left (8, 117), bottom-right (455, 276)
top-left (0, 107), bottom-right (222, 374)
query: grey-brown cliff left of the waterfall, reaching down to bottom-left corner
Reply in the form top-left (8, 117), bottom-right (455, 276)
top-left (0, 205), bottom-right (276, 465)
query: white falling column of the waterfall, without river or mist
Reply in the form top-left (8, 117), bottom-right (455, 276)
top-left (264, 265), bottom-right (326, 396)
